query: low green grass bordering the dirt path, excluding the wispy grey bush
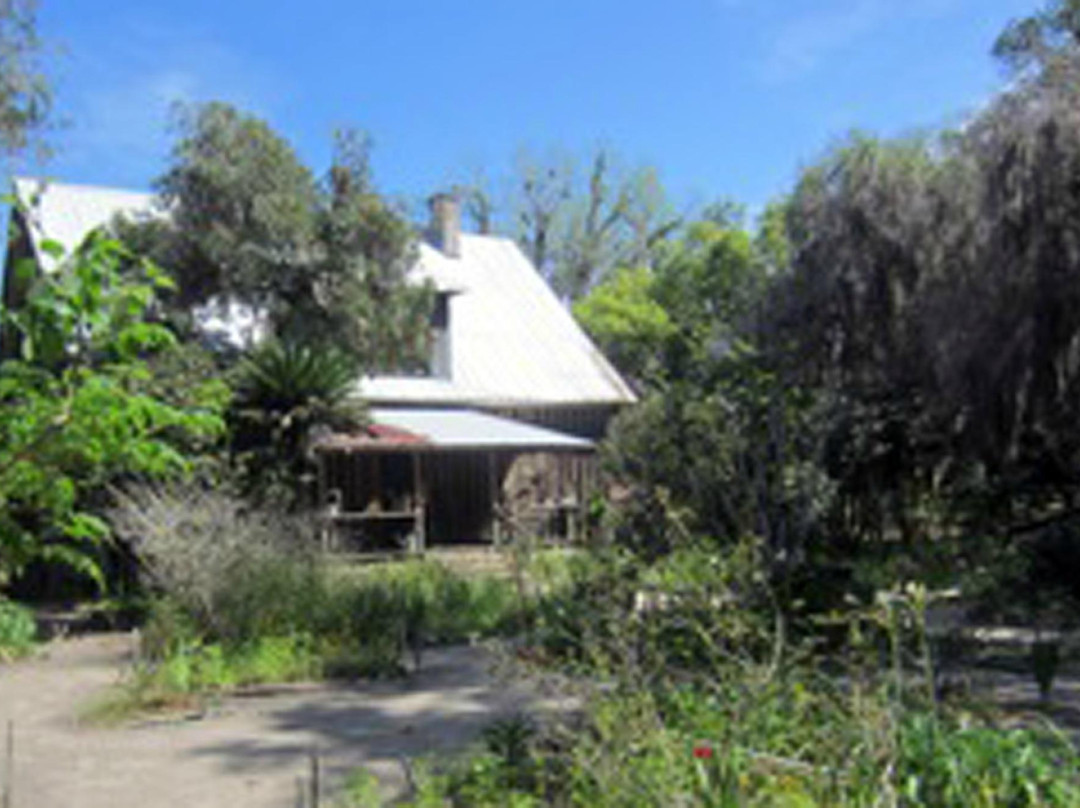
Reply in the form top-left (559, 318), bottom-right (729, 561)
top-left (92, 557), bottom-right (522, 724)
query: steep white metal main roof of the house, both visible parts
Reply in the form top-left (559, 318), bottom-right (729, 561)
top-left (15, 173), bottom-right (635, 406)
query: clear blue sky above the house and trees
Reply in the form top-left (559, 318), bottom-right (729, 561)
top-left (31, 0), bottom-right (1036, 218)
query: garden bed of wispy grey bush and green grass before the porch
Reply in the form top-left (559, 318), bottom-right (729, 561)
top-left (102, 485), bottom-right (519, 714)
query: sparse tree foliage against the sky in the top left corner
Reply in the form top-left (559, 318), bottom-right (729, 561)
top-left (0, 0), bottom-right (52, 156)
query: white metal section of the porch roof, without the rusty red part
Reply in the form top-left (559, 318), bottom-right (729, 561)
top-left (370, 407), bottom-right (593, 452)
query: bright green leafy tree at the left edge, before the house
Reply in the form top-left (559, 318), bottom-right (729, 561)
top-left (0, 234), bottom-right (225, 583)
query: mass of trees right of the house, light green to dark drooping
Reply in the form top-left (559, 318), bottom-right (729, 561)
top-left (591, 14), bottom-right (1080, 617)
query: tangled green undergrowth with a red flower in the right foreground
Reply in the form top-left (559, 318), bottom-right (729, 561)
top-left (341, 535), bottom-right (1080, 808)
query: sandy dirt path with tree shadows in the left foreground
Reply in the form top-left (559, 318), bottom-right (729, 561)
top-left (0, 634), bottom-right (570, 808)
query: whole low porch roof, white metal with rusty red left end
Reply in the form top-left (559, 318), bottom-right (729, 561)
top-left (315, 407), bottom-right (594, 453)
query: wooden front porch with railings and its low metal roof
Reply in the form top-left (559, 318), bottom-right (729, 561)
top-left (316, 408), bottom-right (596, 554)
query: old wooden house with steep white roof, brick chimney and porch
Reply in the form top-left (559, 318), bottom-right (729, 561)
top-left (4, 179), bottom-right (634, 548)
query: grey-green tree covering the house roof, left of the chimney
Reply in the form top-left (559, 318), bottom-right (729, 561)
top-left (122, 103), bottom-right (432, 371)
